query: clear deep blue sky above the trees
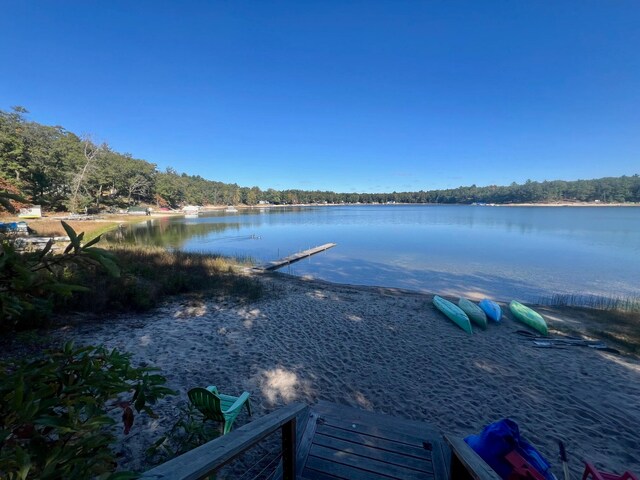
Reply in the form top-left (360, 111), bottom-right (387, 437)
top-left (0, 0), bottom-right (640, 192)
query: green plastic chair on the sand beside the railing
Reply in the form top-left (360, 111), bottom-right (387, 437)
top-left (188, 385), bottom-right (251, 435)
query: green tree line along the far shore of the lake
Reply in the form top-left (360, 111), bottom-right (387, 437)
top-left (0, 107), bottom-right (640, 211)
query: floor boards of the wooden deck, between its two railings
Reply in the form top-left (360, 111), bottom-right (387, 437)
top-left (298, 401), bottom-right (450, 480)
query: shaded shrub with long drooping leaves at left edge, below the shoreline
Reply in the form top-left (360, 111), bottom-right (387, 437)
top-left (0, 222), bottom-right (120, 331)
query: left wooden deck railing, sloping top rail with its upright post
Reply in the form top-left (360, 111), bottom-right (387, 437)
top-left (140, 403), bottom-right (309, 480)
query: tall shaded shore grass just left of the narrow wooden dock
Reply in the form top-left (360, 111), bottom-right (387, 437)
top-left (60, 246), bottom-right (263, 313)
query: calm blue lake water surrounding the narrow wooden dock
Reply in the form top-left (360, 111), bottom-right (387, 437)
top-left (110, 205), bottom-right (640, 301)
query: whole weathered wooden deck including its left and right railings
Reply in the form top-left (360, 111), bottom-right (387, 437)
top-left (140, 402), bottom-right (500, 480)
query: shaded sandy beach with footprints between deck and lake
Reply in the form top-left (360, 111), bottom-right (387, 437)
top-left (42, 274), bottom-right (640, 476)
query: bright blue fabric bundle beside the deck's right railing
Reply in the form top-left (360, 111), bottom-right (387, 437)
top-left (464, 418), bottom-right (556, 480)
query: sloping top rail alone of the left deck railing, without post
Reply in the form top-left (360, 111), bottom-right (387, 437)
top-left (140, 403), bottom-right (307, 480)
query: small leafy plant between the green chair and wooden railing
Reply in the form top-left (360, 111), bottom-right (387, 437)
top-left (147, 404), bottom-right (220, 464)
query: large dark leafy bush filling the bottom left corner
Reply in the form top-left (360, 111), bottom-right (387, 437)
top-left (0, 343), bottom-right (175, 480)
